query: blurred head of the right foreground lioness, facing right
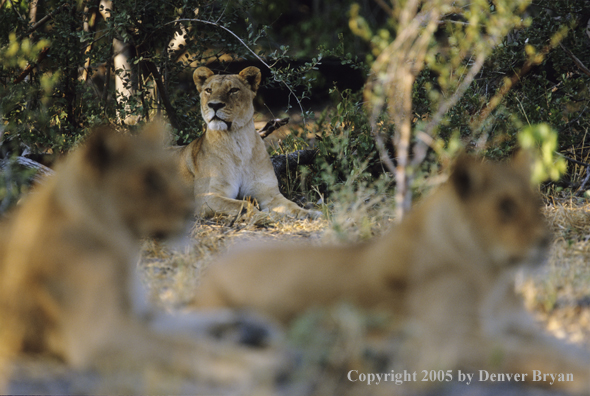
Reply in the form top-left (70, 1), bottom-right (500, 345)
top-left (450, 152), bottom-right (549, 266)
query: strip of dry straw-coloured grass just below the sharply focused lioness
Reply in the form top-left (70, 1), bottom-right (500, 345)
top-left (141, 179), bottom-right (393, 308)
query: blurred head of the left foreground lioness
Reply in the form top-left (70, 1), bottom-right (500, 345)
top-left (80, 122), bottom-right (194, 238)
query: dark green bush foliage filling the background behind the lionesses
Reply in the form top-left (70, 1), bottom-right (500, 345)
top-left (0, 0), bottom-right (590, 213)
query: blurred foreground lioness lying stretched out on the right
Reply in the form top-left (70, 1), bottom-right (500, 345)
top-left (195, 155), bottom-right (590, 393)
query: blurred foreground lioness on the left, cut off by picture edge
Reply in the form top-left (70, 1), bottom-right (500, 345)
top-left (0, 124), bottom-right (284, 393)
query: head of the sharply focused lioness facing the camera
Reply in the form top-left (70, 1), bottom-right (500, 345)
top-left (193, 66), bottom-right (261, 131)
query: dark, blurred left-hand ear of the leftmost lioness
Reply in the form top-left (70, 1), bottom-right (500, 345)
top-left (83, 127), bottom-right (128, 173)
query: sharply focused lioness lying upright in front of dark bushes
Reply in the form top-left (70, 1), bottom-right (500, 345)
top-left (177, 67), bottom-right (321, 218)
